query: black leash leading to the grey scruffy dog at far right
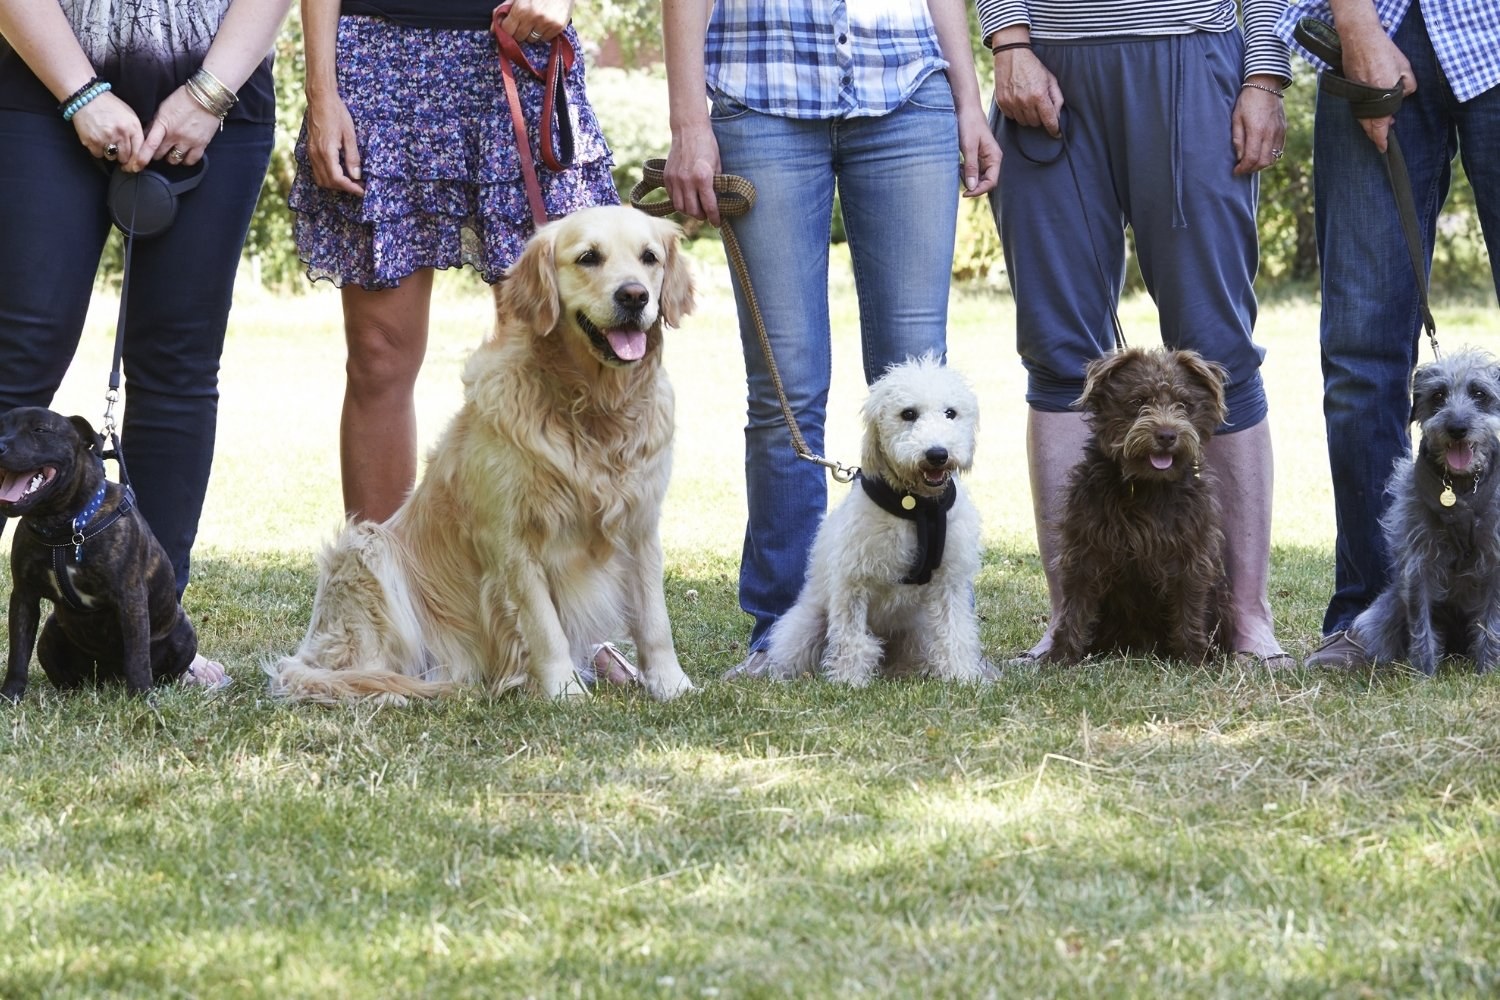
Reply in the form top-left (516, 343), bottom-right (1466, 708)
top-left (1292, 18), bottom-right (1440, 358)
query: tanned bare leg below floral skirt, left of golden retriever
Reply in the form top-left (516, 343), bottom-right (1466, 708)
top-left (339, 268), bottom-right (432, 522)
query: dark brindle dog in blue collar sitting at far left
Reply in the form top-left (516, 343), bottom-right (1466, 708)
top-left (0, 406), bottom-right (198, 702)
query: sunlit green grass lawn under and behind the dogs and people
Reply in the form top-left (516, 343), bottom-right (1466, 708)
top-left (0, 248), bottom-right (1500, 999)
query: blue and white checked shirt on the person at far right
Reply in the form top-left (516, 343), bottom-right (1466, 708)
top-left (1277, 0), bottom-right (1500, 100)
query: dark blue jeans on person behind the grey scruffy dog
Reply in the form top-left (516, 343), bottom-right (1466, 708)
top-left (1313, 3), bottom-right (1500, 634)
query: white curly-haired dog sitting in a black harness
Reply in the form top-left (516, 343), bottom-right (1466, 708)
top-left (767, 354), bottom-right (986, 685)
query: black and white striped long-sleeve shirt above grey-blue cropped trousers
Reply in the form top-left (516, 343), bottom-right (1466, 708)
top-left (975, 0), bottom-right (1292, 79)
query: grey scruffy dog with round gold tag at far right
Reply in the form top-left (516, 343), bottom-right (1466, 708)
top-left (1350, 349), bottom-right (1500, 676)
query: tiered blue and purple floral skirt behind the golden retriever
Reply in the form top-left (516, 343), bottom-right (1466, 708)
top-left (288, 16), bottom-right (620, 288)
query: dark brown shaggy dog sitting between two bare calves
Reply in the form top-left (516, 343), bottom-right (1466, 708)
top-left (1046, 348), bottom-right (1232, 663)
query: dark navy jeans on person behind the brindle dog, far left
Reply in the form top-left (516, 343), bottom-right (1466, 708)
top-left (0, 111), bottom-right (275, 594)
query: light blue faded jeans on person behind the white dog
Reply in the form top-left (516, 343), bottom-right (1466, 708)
top-left (713, 73), bottom-right (959, 649)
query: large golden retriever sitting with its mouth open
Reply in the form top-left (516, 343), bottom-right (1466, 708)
top-left (267, 207), bottom-right (693, 703)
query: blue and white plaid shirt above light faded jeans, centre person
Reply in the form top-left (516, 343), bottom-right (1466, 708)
top-left (704, 0), bottom-right (948, 118)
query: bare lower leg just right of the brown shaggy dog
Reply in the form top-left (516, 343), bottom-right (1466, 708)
top-left (1208, 420), bottom-right (1284, 657)
